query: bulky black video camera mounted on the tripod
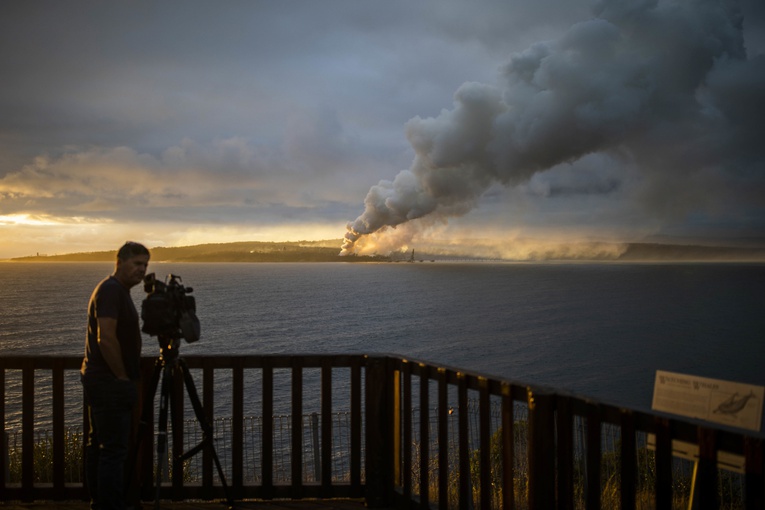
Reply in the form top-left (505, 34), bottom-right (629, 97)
top-left (141, 273), bottom-right (200, 343)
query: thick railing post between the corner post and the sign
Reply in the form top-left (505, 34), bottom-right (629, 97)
top-left (526, 388), bottom-right (555, 510)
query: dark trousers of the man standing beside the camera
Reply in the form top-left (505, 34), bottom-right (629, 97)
top-left (82, 377), bottom-right (138, 510)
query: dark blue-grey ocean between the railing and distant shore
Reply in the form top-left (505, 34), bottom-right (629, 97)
top-left (0, 261), bottom-right (765, 424)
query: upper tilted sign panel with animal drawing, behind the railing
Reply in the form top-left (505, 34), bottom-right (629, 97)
top-left (651, 370), bottom-right (765, 432)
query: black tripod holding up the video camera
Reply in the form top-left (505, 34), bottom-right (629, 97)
top-left (129, 335), bottom-right (233, 510)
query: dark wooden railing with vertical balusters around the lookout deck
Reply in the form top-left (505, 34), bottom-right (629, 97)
top-left (0, 355), bottom-right (765, 510)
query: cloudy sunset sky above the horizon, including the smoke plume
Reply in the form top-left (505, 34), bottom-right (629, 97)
top-left (0, 0), bottom-right (765, 259)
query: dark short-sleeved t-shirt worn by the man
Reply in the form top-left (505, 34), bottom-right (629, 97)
top-left (81, 276), bottom-right (141, 380)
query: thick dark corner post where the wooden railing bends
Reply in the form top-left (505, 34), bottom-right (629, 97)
top-left (364, 357), bottom-right (393, 508)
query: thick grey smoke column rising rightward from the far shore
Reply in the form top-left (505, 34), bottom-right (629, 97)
top-left (341, 0), bottom-right (765, 254)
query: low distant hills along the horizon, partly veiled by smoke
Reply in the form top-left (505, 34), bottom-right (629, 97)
top-left (11, 239), bottom-right (765, 262)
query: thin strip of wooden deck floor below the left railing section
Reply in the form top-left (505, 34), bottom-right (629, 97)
top-left (0, 499), bottom-right (365, 510)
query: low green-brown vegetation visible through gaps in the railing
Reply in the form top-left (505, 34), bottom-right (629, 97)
top-left (7, 416), bottom-right (745, 510)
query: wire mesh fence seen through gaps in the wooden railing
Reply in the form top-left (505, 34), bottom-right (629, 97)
top-left (2, 401), bottom-right (744, 510)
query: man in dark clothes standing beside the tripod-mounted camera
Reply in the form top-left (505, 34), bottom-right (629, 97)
top-left (81, 242), bottom-right (149, 510)
